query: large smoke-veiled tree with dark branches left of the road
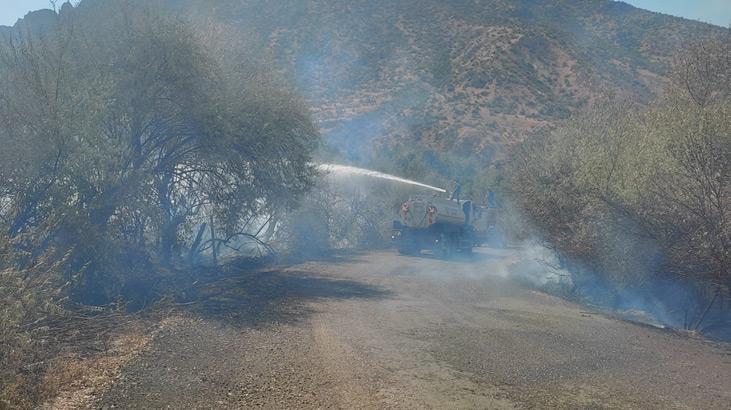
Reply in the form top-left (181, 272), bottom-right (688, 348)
top-left (0, 2), bottom-right (318, 300)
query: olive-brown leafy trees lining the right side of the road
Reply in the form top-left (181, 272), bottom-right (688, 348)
top-left (508, 32), bottom-right (731, 331)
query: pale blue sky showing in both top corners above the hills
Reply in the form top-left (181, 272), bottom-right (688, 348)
top-left (0, 0), bottom-right (731, 27)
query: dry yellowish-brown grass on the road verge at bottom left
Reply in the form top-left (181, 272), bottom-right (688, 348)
top-left (0, 314), bottom-right (161, 409)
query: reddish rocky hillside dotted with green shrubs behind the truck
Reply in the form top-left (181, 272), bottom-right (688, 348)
top-left (4, 0), bottom-right (718, 159)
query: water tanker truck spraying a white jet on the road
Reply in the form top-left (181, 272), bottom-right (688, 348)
top-left (391, 195), bottom-right (502, 258)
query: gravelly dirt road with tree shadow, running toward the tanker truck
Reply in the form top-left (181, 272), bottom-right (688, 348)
top-left (95, 251), bottom-right (731, 409)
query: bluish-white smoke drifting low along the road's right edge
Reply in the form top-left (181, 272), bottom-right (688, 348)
top-left (452, 201), bottom-right (694, 329)
